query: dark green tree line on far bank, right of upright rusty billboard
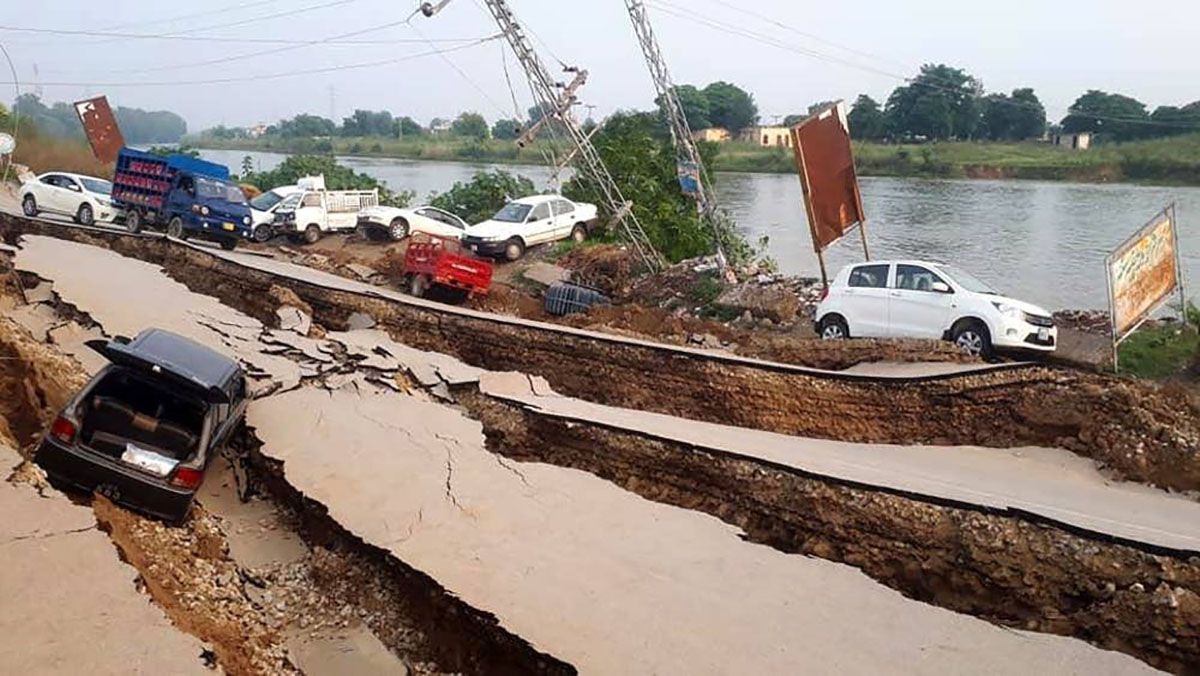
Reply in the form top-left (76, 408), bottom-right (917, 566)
top-left (850, 64), bottom-right (1200, 142)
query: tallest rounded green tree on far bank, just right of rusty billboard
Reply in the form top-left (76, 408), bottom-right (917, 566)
top-left (884, 64), bottom-right (983, 139)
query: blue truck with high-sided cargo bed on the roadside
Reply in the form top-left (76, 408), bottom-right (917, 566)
top-left (113, 148), bottom-right (252, 250)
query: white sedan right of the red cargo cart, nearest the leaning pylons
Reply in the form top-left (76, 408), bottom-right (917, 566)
top-left (462, 195), bottom-right (596, 261)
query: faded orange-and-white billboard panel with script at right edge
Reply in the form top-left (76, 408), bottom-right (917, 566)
top-left (1105, 204), bottom-right (1183, 343)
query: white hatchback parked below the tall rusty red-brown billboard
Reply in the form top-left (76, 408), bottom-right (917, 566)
top-left (815, 261), bottom-right (1058, 357)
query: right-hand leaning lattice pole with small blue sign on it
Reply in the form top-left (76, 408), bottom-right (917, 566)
top-left (625, 0), bottom-right (728, 270)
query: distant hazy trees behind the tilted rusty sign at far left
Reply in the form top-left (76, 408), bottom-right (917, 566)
top-left (13, 94), bottom-right (187, 145)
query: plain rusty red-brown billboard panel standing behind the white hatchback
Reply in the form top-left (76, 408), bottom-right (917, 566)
top-left (792, 101), bottom-right (866, 265)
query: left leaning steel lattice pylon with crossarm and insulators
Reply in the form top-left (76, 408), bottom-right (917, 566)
top-left (421, 0), bottom-right (664, 271)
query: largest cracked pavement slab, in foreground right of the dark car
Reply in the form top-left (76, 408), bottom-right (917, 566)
top-left (248, 385), bottom-right (1151, 674)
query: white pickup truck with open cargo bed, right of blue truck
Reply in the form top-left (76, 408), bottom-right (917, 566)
top-left (271, 176), bottom-right (379, 244)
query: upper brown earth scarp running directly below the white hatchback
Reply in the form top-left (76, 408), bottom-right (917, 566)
top-left (0, 219), bottom-right (1200, 490)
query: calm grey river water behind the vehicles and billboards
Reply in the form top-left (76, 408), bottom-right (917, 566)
top-left (203, 150), bottom-right (1200, 309)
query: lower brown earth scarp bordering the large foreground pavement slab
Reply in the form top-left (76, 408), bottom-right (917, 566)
top-left (456, 390), bottom-right (1200, 674)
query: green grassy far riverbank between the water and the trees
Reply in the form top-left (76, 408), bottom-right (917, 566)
top-left (184, 134), bottom-right (1200, 185)
